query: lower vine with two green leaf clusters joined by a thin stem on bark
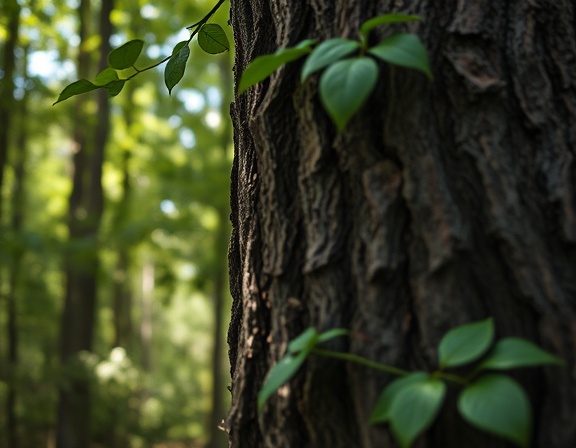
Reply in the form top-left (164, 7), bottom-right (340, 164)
top-left (258, 318), bottom-right (561, 448)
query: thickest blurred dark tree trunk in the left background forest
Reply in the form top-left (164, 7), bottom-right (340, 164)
top-left (57, 0), bottom-right (113, 448)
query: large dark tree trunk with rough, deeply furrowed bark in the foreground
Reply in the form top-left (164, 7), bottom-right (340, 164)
top-left (228, 0), bottom-right (576, 448)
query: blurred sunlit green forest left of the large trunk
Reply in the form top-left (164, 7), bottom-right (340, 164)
top-left (0, 0), bottom-right (232, 448)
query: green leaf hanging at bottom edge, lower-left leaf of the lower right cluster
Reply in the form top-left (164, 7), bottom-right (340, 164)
top-left (389, 378), bottom-right (446, 448)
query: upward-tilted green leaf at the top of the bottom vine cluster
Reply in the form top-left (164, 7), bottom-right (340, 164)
top-left (438, 318), bottom-right (494, 368)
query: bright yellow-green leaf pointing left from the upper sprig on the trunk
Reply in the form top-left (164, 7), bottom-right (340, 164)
top-left (238, 39), bottom-right (315, 95)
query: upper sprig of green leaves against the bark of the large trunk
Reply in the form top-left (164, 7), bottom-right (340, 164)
top-left (238, 14), bottom-right (432, 131)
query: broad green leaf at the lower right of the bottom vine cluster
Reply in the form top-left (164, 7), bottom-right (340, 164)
top-left (458, 375), bottom-right (531, 448)
